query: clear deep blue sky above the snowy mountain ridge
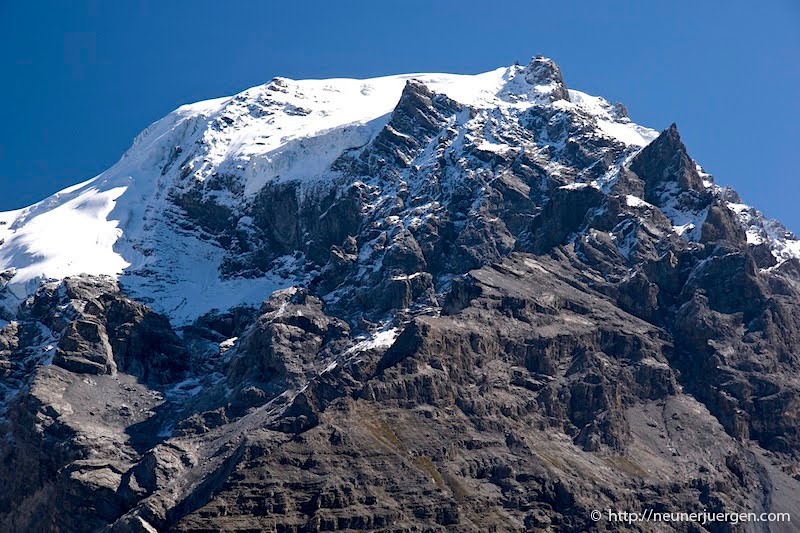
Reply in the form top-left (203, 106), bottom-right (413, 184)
top-left (0, 0), bottom-right (800, 232)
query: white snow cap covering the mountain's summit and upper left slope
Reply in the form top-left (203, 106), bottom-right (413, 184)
top-left (0, 56), bottom-right (796, 322)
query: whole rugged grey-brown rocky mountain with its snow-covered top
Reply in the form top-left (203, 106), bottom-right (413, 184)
top-left (0, 57), bottom-right (800, 532)
